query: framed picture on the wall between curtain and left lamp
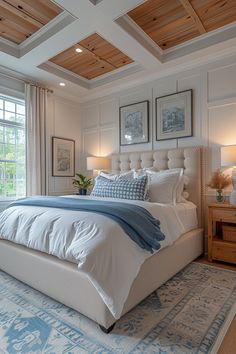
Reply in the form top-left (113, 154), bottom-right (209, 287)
top-left (52, 136), bottom-right (75, 177)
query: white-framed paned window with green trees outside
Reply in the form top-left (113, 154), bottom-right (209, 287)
top-left (0, 94), bottom-right (26, 199)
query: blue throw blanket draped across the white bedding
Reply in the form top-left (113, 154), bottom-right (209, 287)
top-left (8, 197), bottom-right (165, 253)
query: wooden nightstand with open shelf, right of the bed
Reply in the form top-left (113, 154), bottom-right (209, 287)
top-left (208, 203), bottom-right (236, 264)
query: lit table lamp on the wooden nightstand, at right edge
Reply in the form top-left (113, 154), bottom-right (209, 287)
top-left (221, 145), bottom-right (236, 204)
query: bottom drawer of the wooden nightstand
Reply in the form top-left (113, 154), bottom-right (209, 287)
top-left (212, 241), bottom-right (236, 264)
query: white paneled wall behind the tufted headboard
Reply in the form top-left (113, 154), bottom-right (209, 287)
top-left (81, 56), bottom-right (236, 192)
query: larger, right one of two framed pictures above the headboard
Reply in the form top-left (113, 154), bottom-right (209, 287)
top-left (155, 89), bottom-right (193, 141)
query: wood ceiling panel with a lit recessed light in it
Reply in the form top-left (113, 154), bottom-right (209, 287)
top-left (50, 33), bottom-right (133, 80)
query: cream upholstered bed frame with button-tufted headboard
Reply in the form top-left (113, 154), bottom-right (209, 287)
top-left (0, 148), bottom-right (203, 329)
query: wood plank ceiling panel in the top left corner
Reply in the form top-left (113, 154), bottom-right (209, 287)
top-left (0, 0), bottom-right (62, 44)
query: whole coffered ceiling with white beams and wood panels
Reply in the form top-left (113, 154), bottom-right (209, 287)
top-left (0, 0), bottom-right (236, 99)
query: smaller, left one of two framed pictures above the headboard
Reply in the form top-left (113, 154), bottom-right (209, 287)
top-left (119, 100), bottom-right (149, 146)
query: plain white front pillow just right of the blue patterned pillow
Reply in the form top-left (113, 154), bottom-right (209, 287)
top-left (146, 168), bottom-right (183, 204)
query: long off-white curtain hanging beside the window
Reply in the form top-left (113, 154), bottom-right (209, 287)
top-left (25, 84), bottom-right (47, 196)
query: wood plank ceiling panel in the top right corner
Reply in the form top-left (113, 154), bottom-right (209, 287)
top-left (128, 0), bottom-right (236, 49)
